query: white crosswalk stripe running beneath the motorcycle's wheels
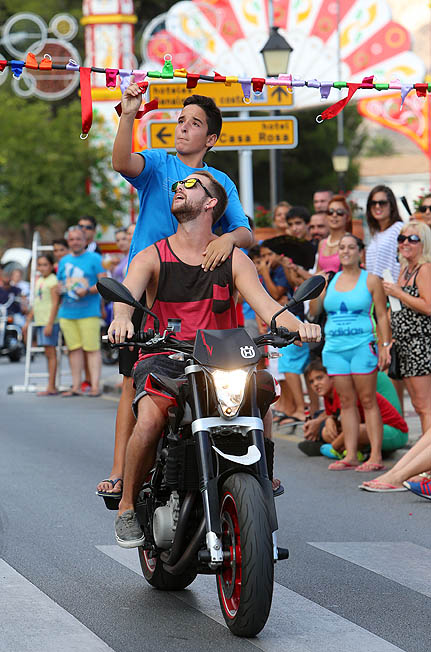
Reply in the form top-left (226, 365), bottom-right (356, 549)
top-left (96, 546), bottom-right (402, 652)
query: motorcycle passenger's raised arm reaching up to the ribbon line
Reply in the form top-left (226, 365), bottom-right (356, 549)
top-left (112, 84), bottom-right (145, 178)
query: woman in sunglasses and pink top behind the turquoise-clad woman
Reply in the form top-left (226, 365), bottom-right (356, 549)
top-left (317, 195), bottom-right (352, 274)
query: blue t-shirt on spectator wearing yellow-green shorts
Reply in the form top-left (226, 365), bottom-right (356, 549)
top-left (57, 251), bottom-right (105, 319)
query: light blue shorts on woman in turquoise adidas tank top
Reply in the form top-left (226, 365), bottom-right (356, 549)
top-left (322, 342), bottom-right (379, 376)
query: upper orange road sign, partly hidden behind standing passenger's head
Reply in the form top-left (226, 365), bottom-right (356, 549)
top-left (149, 80), bottom-right (293, 111)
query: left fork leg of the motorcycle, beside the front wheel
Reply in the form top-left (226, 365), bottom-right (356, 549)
top-left (189, 372), bottom-right (223, 568)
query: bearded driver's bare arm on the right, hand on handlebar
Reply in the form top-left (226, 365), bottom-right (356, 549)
top-left (232, 249), bottom-right (320, 342)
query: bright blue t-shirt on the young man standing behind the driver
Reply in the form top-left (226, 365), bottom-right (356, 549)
top-left (123, 149), bottom-right (250, 263)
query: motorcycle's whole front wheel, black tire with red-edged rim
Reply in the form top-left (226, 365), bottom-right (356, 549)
top-left (217, 473), bottom-right (274, 637)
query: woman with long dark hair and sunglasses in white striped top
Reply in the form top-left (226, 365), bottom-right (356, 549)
top-left (365, 186), bottom-right (403, 281)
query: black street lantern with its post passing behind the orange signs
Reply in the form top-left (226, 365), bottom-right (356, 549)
top-left (260, 26), bottom-right (293, 207)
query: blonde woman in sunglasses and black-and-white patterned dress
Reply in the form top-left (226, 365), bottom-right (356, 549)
top-left (383, 221), bottom-right (431, 433)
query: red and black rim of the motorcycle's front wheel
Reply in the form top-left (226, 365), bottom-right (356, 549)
top-left (217, 492), bottom-right (241, 618)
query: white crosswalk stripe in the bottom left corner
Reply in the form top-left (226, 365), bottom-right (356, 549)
top-left (0, 559), bottom-right (113, 652)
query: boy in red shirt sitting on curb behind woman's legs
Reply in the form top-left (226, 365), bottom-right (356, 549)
top-left (298, 360), bottom-right (408, 459)
